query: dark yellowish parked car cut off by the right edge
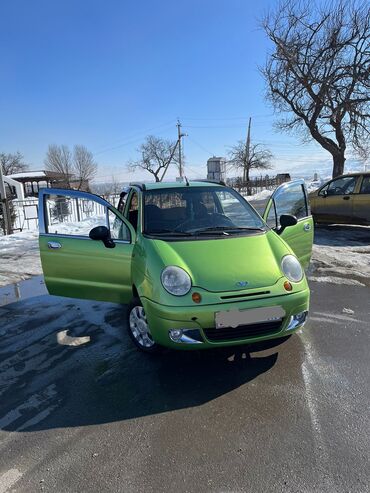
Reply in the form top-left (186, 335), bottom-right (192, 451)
top-left (309, 173), bottom-right (370, 225)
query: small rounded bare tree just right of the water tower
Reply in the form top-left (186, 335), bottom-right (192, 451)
top-left (228, 140), bottom-right (273, 182)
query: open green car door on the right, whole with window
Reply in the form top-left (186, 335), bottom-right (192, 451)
top-left (263, 180), bottom-right (314, 269)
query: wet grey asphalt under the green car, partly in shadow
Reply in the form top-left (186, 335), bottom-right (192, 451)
top-left (0, 283), bottom-right (370, 493)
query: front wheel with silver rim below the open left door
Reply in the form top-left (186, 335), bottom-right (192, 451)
top-left (127, 298), bottom-right (161, 354)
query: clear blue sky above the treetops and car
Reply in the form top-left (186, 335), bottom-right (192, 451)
top-left (0, 0), bottom-right (330, 181)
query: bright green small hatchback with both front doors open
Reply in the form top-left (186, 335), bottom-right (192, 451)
top-left (39, 180), bottom-right (313, 352)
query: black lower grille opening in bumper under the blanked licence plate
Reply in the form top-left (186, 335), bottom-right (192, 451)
top-left (204, 320), bottom-right (282, 342)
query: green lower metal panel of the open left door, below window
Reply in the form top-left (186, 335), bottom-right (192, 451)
top-left (39, 234), bottom-right (133, 303)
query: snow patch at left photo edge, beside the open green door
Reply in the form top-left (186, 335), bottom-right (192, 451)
top-left (0, 231), bottom-right (42, 286)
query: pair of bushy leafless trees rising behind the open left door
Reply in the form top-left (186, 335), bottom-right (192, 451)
top-left (44, 144), bottom-right (97, 190)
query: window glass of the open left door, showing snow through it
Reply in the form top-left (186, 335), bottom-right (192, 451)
top-left (45, 195), bottom-right (108, 236)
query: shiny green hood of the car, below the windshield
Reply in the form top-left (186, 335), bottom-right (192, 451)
top-left (154, 231), bottom-right (290, 292)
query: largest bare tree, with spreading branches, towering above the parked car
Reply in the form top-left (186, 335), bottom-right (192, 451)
top-left (261, 0), bottom-right (370, 177)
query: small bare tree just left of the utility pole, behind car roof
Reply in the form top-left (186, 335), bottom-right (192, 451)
top-left (128, 135), bottom-right (178, 181)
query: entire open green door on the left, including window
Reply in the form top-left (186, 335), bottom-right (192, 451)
top-left (39, 188), bottom-right (136, 303)
